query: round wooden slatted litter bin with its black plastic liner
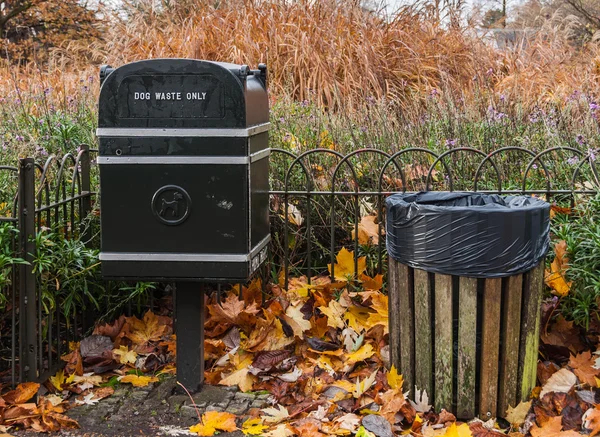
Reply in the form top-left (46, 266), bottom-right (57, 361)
top-left (386, 192), bottom-right (550, 419)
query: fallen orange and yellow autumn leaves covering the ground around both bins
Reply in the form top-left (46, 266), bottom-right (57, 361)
top-left (0, 249), bottom-right (600, 437)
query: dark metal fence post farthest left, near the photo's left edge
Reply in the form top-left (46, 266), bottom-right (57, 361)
top-left (19, 158), bottom-right (38, 381)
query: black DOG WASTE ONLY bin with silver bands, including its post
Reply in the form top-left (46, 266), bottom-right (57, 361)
top-left (97, 59), bottom-right (270, 391)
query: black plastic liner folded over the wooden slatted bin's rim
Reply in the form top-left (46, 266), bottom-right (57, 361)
top-left (386, 192), bottom-right (550, 278)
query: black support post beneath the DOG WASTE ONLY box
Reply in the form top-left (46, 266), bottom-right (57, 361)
top-left (175, 282), bottom-right (204, 392)
